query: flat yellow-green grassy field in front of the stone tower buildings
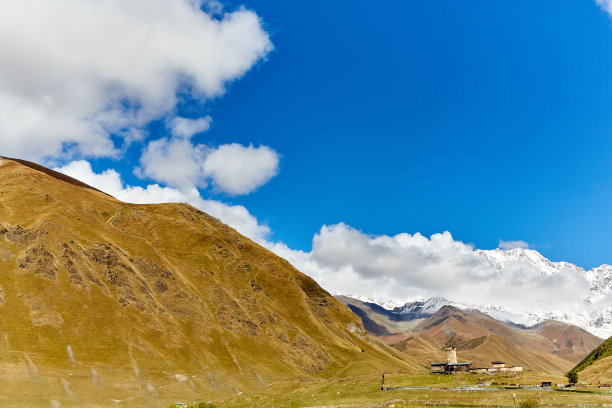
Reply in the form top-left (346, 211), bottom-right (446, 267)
top-left (208, 372), bottom-right (612, 408)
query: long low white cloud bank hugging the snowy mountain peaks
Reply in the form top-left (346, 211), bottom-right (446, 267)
top-left (270, 223), bottom-right (589, 312)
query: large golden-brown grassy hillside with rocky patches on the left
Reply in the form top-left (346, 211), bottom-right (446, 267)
top-left (0, 158), bottom-right (414, 407)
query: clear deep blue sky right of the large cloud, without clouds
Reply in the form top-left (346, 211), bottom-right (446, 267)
top-left (128, 0), bottom-right (612, 267)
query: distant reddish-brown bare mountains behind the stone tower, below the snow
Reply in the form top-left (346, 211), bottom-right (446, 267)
top-left (338, 297), bottom-right (603, 374)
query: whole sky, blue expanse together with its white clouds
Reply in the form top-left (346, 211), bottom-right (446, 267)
top-left (0, 0), bottom-right (612, 310)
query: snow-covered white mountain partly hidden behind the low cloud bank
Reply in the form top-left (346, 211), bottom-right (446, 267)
top-left (384, 248), bottom-right (612, 338)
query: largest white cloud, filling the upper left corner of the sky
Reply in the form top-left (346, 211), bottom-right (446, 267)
top-left (0, 0), bottom-right (272, 160)
